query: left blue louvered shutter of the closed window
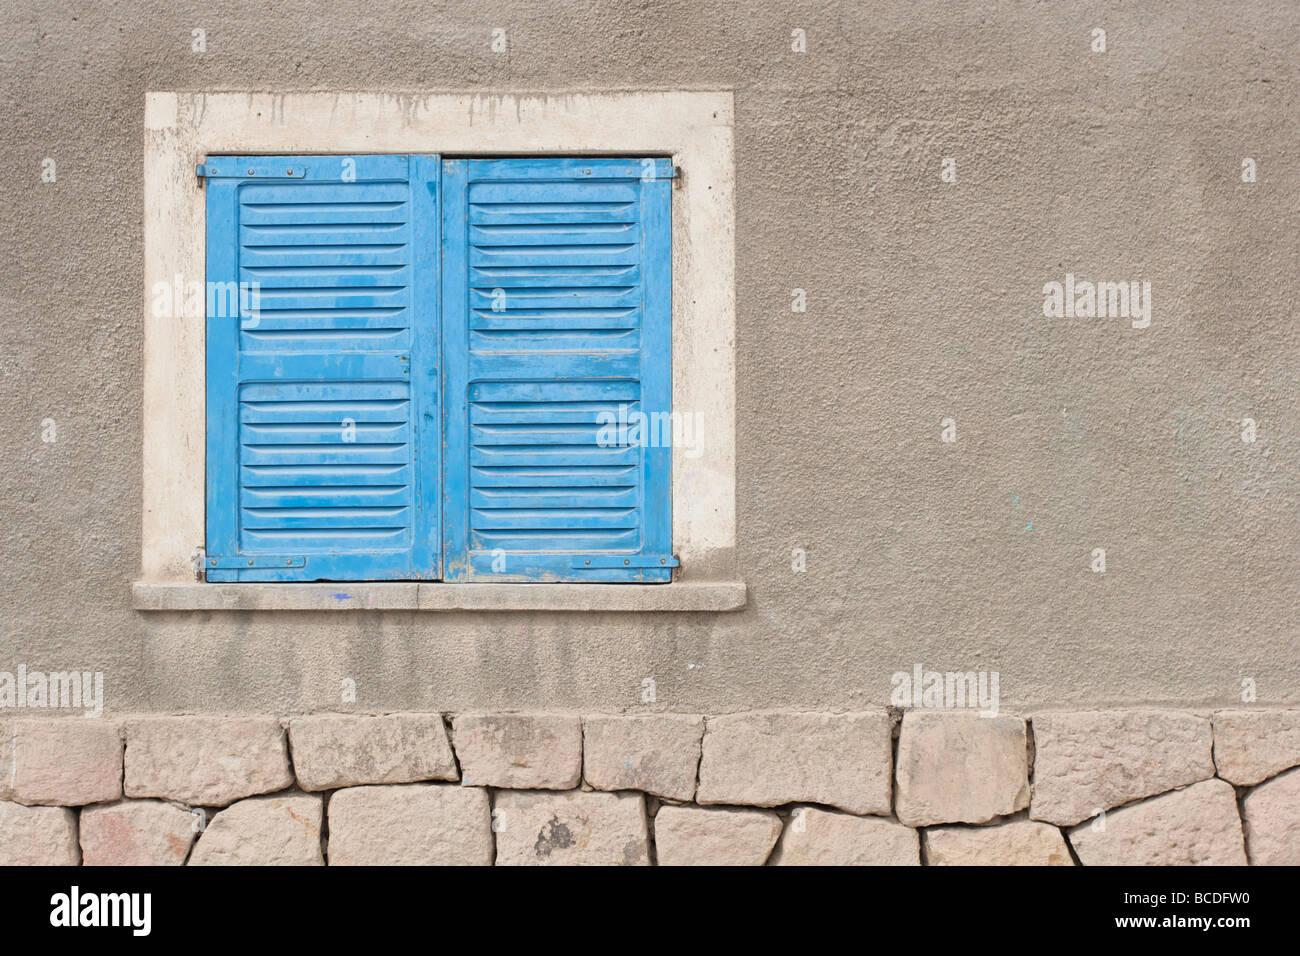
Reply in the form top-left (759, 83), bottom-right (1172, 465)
top-left (200, 156), bottom-right (442, 581)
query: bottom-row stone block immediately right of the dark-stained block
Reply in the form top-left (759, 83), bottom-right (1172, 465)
top-left (654, 806), bottom-right (781, 866)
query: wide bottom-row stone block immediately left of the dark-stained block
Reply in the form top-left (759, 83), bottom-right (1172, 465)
top-left (329, 783), bottom-right (493, 866)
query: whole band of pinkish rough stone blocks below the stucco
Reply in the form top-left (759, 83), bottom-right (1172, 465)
top-left (0, 710), bottom-right (1300, 866)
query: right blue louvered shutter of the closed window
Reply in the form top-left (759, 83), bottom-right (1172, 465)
top-left (442, 159), bottom-right (676, 581)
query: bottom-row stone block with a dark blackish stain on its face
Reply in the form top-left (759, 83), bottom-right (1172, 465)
top-left (494, 791), bottom-right (650, 866)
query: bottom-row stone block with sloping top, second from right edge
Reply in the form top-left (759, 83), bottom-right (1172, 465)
top-left (1070, 780), bottom-right (1245, 866)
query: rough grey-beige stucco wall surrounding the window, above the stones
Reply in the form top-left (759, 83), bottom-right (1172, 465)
top-left (0, 0), bottom-right (1300, 713)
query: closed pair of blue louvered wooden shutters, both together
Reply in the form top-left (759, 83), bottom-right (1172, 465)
top-left (200, 155), bottom-right (677, 583)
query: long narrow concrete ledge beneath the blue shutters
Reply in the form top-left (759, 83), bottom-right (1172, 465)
top-left (131, 581), bottom-right (746, 611)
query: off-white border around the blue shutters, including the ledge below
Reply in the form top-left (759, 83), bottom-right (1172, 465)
top-left (134, 91), bottom-right (745, 610)
